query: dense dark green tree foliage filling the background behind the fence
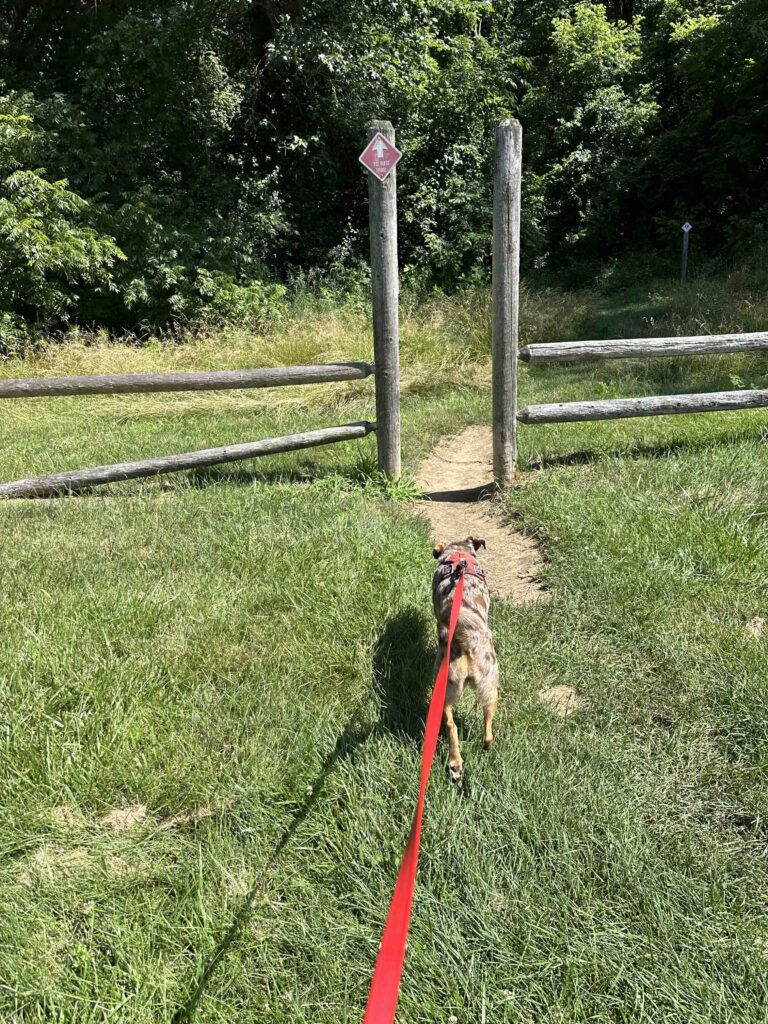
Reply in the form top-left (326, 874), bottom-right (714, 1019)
top-left (0, 0), bottom-right (768, 328)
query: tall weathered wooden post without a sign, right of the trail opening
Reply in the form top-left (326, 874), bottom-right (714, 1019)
top-left (493, 118), bottom-right (522, 487)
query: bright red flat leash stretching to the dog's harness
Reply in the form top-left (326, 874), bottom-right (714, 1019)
top-left (362, 566), bottom-right (466, 1024)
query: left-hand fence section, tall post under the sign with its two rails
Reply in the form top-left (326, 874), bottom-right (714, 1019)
top-left (0, 121), bottom-right (400, 499)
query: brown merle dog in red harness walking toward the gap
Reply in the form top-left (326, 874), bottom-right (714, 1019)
top-left (432, 537), bottom-right (499, 781)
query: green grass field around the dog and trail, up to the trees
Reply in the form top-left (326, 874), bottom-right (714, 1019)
top-left (0, 278), bottom-right (768, 1024)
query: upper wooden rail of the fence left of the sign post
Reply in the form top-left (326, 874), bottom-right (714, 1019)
top-left (0, 362), bottom-right (375, 398)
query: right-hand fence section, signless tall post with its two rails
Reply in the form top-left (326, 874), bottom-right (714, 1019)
top-left (493, 119), bottom-right (768, 486)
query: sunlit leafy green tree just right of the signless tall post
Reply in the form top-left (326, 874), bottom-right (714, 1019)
top-left (523, 3), bottom-right (657, 260)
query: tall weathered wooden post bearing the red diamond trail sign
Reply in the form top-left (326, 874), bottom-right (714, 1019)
top-left (368, 121), bottom-right (400, 479)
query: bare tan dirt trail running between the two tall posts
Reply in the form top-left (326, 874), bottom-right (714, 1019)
top-left (416, 427), bottom-right (544, 604)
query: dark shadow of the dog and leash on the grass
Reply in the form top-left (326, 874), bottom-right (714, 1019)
top-left (172, 608), bottom-right (433, 1024)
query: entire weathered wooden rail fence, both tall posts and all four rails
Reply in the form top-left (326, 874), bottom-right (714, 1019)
top-left (6, 119), bottom-right (768, 498)
